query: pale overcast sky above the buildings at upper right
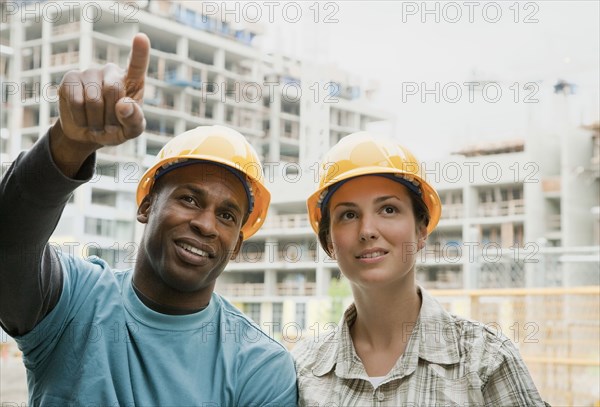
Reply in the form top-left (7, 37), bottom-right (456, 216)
top-left (262, 1), bottom-right (600, 159)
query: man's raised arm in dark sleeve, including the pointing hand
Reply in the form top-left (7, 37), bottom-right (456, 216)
top-left (0, 34), bottom-right (150, 336)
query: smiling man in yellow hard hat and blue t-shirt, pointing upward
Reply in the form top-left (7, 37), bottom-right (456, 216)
top-left (0, 34), bottom-right (296, 406)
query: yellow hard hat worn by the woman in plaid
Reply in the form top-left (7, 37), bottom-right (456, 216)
top-left (306, 131), bottom-right (442, 234)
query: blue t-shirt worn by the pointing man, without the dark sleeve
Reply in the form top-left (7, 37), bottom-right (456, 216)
top-left (16, 254), bottom-right (297, 407)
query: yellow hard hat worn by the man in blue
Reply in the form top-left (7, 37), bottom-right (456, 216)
top-left (136, 126), bottom-right (271, 239)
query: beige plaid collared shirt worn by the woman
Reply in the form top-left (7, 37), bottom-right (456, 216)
top-left (292, 289), bottom-right (545, 407)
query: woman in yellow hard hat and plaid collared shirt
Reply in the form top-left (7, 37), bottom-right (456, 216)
top-left (293, 132), bottom-right (544, 407)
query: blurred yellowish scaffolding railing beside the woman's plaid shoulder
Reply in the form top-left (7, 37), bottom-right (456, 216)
top-left (431, 286), bottom-right (600, 406)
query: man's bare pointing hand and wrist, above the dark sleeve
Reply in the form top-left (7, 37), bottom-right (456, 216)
top-left (50, 34), bottom-right (150, 177)
